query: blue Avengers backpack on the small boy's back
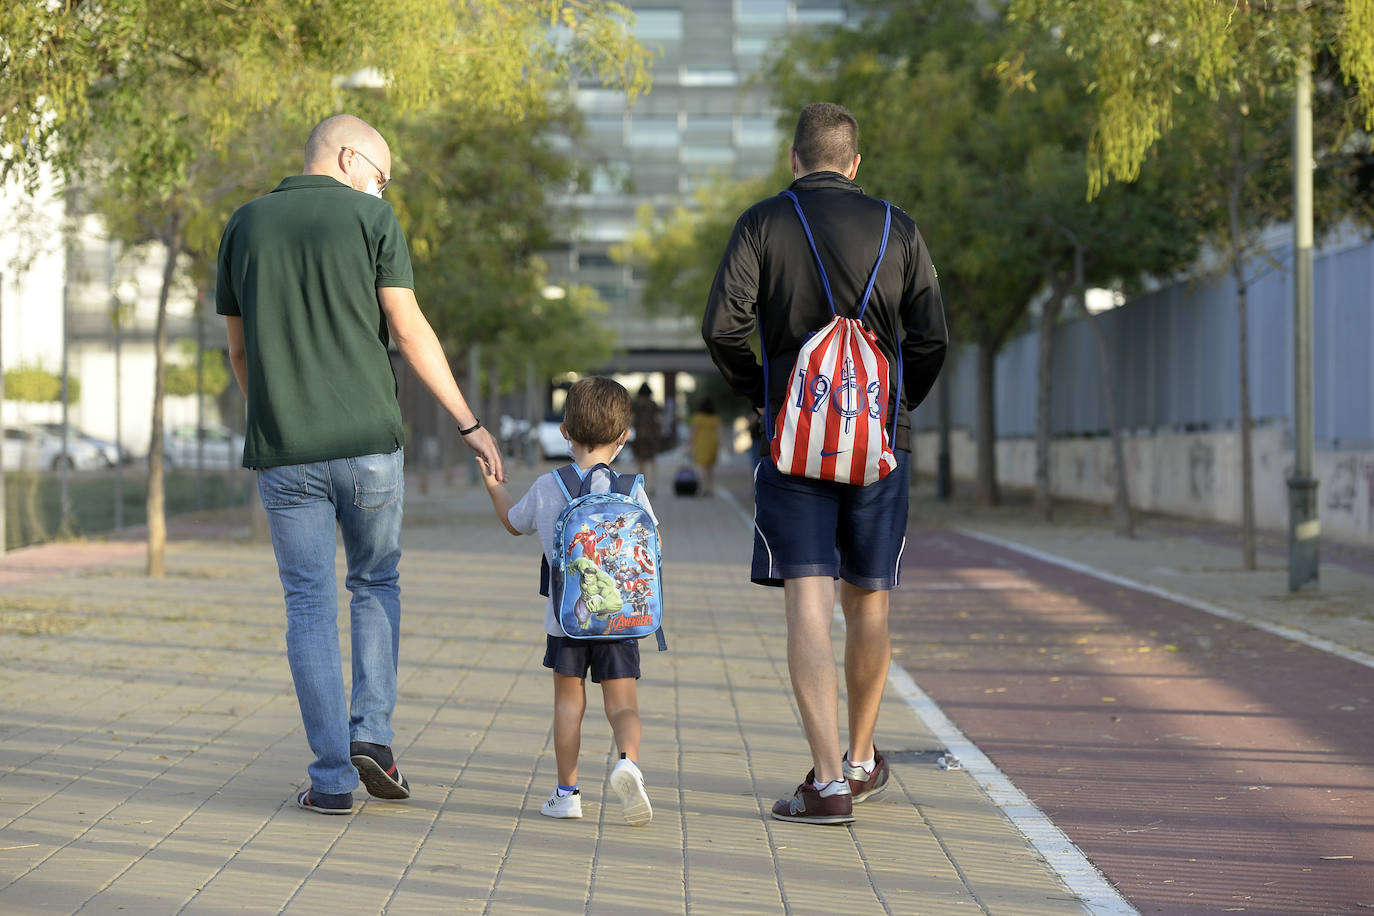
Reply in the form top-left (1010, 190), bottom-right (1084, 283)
top-left (539, 464), bottom-right (668, 652)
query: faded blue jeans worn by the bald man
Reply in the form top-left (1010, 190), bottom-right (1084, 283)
top-left (258, 449), bottom-right (405, 792)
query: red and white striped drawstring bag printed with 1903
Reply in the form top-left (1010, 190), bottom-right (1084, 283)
top-left (772, 191), bottom-right (901, 486)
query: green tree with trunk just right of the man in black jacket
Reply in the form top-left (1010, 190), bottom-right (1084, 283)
top-left (775, 1), bottom-right (1115, 504)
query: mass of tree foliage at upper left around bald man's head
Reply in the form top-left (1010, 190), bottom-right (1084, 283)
top-left (0, 0), bottom-right (649, 391)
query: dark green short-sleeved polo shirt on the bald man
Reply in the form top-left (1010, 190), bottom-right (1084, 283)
top-left (214, 174), bottom-right (415, 467)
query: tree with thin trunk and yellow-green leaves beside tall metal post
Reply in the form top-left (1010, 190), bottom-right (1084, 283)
top-left (1003, 0), bottom-right (1374, 570)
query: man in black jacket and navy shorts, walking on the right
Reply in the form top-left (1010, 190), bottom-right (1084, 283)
top-left (702, 103), bottom-right (947, 824)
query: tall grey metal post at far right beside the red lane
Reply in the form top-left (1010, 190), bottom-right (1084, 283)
top-left (1287, 41), bottom-right (1322, 592)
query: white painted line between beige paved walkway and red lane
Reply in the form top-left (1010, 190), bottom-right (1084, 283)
top-left (716, 480), bottom-right (1140, 916)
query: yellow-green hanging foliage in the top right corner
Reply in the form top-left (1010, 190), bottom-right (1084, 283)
top-left (999, 0), bottom-right (1374, 195)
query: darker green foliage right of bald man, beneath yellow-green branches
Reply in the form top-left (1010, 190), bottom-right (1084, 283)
top-left (387, 96), bottom-right (614, 387)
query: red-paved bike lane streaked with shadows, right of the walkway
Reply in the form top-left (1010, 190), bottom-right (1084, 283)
top-left (879, 529), bottom-right (1374, 916)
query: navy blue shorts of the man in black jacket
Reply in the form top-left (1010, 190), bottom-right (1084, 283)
top-left (749, 449), bottom-right (911, 589)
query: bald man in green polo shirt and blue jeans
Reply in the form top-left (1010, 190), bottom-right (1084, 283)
top-left (216, 114), bottom-right (506, 814)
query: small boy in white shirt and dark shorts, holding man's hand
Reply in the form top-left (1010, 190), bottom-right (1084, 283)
top-left (478, 378), bottom-right (658, 827)
